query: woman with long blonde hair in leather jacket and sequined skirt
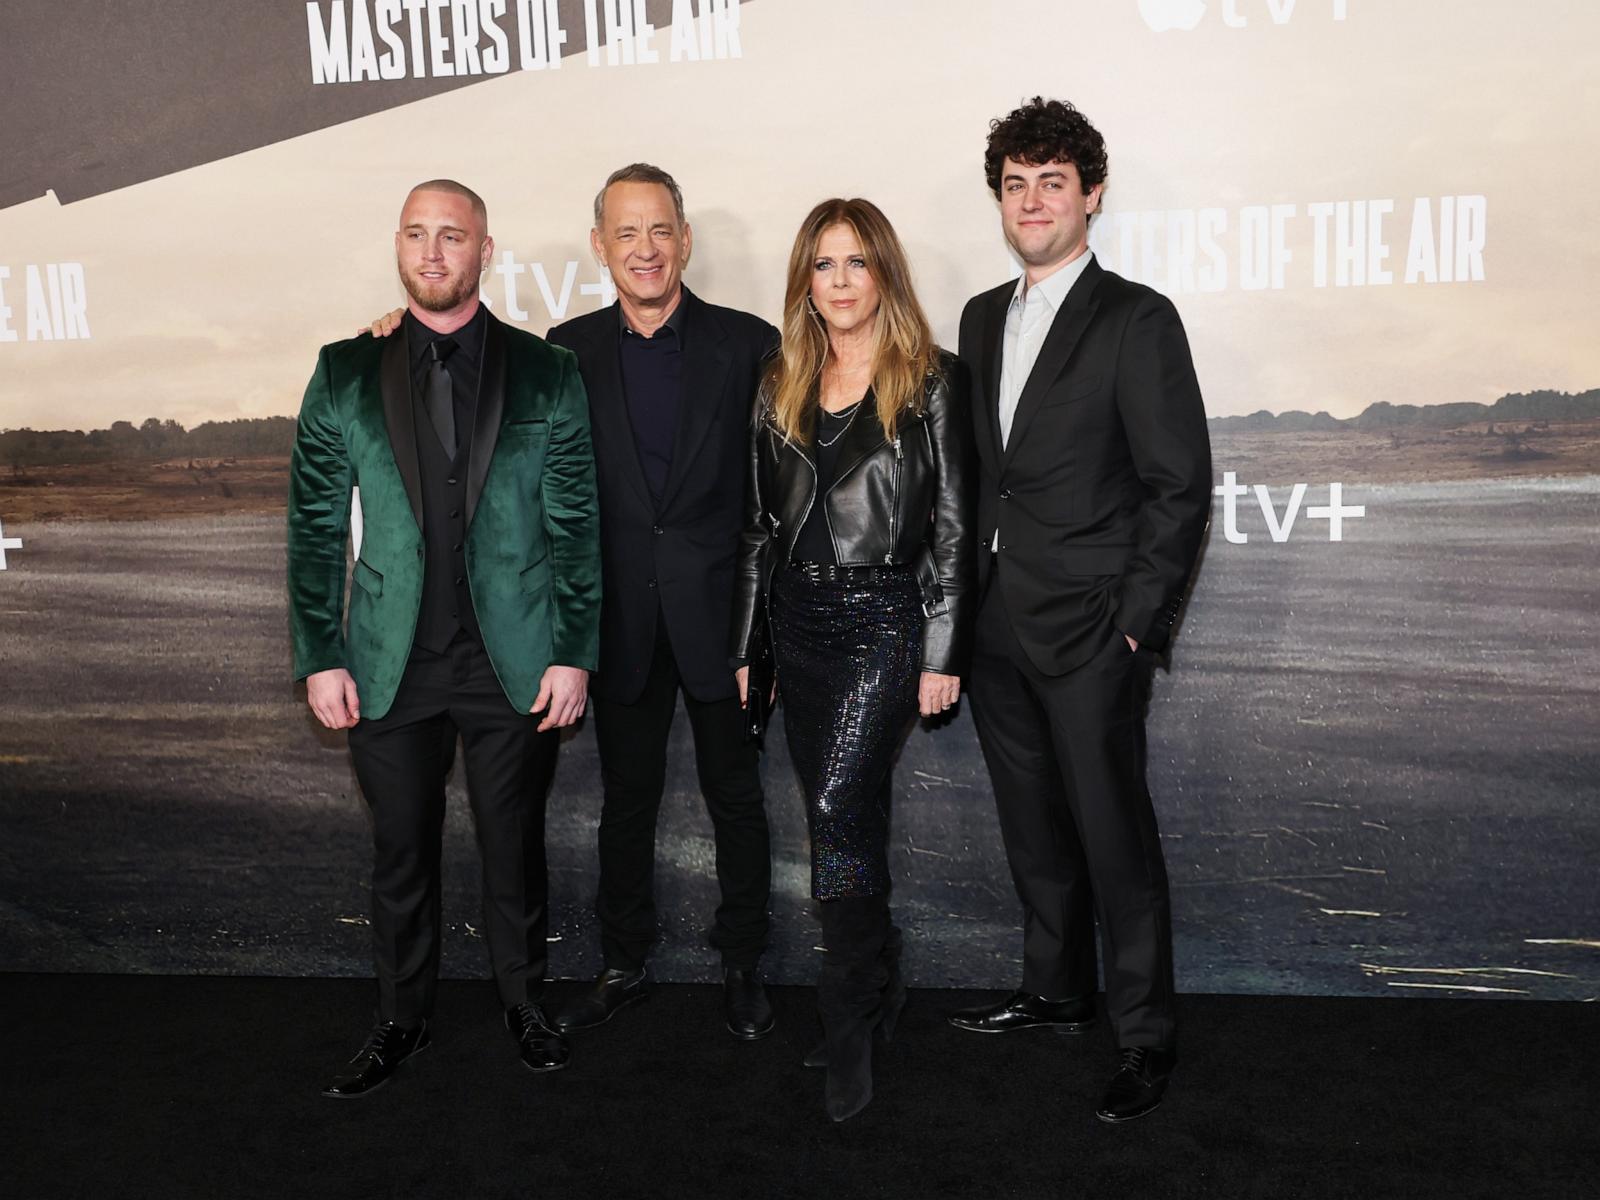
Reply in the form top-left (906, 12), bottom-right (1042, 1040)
top-left (733, 200), bottom-right (976, 1120)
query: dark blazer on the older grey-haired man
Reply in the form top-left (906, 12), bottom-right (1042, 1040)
top-left (546, 288), bottom-right (778, 704)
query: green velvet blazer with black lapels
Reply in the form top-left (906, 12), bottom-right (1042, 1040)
top-left (288, 315), bottom-right (600, 718)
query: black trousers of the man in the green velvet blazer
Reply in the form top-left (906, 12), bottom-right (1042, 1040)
top-left (350, 634), bottom-right (560, 1024)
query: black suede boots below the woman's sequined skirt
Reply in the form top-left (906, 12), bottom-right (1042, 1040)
top-left (816, 896), bottom-right (904, 1122)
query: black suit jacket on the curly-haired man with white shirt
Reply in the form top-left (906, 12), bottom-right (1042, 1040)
top-left (960, 261), bottom-right (1211, 675)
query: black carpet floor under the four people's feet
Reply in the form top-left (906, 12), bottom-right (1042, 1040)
top-left (0, 974), bottom-right (1600, 1200)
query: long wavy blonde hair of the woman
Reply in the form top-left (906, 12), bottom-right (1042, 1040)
top-left (763, 198), bottom-right (939, 445)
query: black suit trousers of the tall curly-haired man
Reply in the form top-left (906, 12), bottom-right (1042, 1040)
top-left (968, 562), bottom-right (1176, 1046)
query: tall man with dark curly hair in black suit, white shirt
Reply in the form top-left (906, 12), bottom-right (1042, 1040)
top-left (950, 98), bottom-right (1211, 1122)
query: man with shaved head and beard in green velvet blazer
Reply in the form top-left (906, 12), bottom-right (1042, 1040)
top-left (288, 179), bottom-right (600, 1099)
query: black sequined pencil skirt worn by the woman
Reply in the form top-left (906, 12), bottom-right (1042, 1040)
top-left (770, 566), bottom-right (922, 899)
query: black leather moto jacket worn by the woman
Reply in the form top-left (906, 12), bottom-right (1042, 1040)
top-left (731, 352), bottom-right (976, 675)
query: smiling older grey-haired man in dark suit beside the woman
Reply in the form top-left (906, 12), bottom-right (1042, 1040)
top-left (549, 163), bottom-right (778, 1038)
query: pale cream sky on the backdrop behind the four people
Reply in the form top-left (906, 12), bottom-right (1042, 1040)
top-left (0, 0), bottom-right (1600, 429)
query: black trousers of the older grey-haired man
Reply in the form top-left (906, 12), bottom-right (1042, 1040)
top-left (590, 614), bottom-right (773, 971)
